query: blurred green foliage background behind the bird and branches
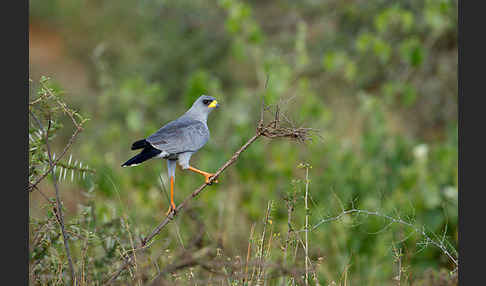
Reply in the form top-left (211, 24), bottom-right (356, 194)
top-left (29, 0), bottom-right (458, 285)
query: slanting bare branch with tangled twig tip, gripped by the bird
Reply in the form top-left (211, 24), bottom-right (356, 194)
top-left (106, 98), bottom-right (315, 285)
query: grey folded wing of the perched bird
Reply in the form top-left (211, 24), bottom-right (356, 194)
top-left (146, 118), bottom-right (209, 154)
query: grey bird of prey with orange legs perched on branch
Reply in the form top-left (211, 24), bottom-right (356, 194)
top-left (122, 95), bottom-right (219, 213)
